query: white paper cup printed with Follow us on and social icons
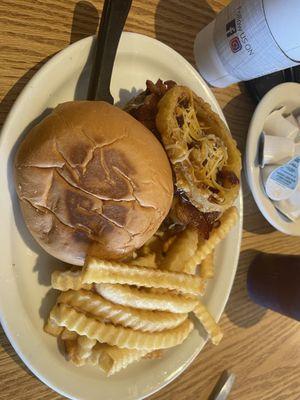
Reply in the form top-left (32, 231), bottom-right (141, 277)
top-left (194, 0), bottom-right (300, 87)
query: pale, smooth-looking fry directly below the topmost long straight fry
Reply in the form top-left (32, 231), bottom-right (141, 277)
top-left (95, 283), bottom-right (197, 313)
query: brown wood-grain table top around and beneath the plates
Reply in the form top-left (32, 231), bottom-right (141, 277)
top-left (0, 0), bottom-right (300, 400)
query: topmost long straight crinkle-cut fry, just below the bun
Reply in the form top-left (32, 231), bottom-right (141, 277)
top-left (82, 257), bottom-right (204, 295)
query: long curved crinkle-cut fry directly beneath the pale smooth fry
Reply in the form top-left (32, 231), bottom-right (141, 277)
top-left (57, 290), bottom-right (188, 332)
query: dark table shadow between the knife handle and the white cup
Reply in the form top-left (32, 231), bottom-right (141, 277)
top-left (155, 0), bottom-right (215, 64)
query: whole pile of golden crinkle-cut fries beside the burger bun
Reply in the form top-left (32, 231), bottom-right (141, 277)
top-left (44, 207), bottom-right (238, 376)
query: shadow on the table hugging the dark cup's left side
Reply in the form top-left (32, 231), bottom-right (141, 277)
top-left (225, 250), bottom-right (267, 328)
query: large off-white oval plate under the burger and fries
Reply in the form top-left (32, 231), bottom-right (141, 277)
top-left (0, 32), bottom-right (242, 400)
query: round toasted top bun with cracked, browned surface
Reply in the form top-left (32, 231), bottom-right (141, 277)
top-left (15, 101), bottom-right (173, 265)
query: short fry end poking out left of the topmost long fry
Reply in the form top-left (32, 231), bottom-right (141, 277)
top-left (51, 270), bottom-right (92, 291)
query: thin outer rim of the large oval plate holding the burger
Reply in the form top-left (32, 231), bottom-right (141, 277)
top-left (0, 31), bottom-right (243, 400)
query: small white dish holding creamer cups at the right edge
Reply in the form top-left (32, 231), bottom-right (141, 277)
top-left (245, 83), bottom-right (300, 236)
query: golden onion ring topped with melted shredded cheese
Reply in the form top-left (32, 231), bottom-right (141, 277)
top-left (156, 86), bottom-right (241, 212)
